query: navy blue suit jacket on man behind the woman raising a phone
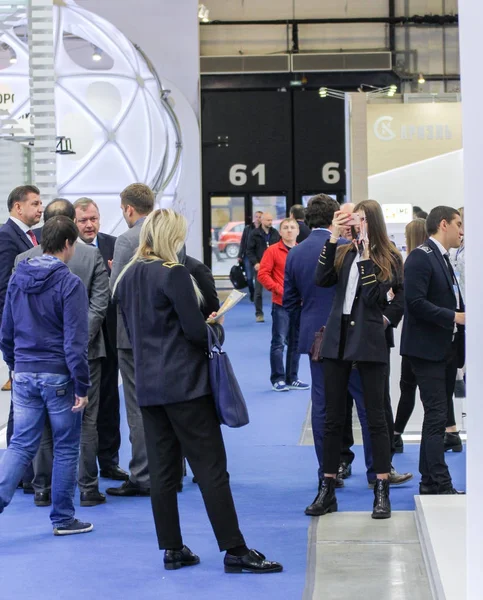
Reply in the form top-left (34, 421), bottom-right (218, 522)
top-left (283, 229), bottom-right (335, 354)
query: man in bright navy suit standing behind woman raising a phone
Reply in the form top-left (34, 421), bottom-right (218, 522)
top-left (283, 194), bottom-right (375, 510)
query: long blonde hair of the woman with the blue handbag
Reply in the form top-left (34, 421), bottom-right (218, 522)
top-left (113, 208), bottom-right (204, 305)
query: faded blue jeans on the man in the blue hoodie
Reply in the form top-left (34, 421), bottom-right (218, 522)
top-left (0, 373), bottom-right (82, 527)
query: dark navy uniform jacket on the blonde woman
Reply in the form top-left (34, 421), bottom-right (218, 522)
top-left (115, 261), bottom-right (223, 406)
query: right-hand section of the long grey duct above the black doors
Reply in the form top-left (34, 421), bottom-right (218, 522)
top-left (292, 52), bottom-right (392, 73)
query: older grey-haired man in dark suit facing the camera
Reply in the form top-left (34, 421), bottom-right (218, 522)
top-left (74, 198), bottom-right (129, 481)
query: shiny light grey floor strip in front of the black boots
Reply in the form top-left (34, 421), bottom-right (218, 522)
top-left (303, 511), bottom-right (432, 600)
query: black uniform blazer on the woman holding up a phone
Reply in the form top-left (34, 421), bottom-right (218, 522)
top-left (316, 241), bottom-right (403, 363)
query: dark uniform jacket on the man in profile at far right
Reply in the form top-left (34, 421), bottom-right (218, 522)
top-left (401, 239), bottom-right (465, 363)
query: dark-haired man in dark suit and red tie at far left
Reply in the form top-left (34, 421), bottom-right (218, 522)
top-left (0, 185), bottom-right (42, 492)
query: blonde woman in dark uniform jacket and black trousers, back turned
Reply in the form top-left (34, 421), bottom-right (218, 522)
top-left (114, 209), bottom-right (282, 573)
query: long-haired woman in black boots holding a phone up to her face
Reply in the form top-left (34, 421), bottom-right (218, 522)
top-left (316, 200), bottom-right (403, 519)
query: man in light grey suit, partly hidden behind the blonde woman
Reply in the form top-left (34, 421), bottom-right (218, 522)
top-left (106, 183), bottom-right (154, 497)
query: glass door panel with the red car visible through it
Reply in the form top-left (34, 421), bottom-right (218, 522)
top-left (211, 196), bottom-right (245, 276)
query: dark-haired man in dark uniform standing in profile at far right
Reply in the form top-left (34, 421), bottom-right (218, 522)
top-left (401, 206), bottom-right (465, 494)
